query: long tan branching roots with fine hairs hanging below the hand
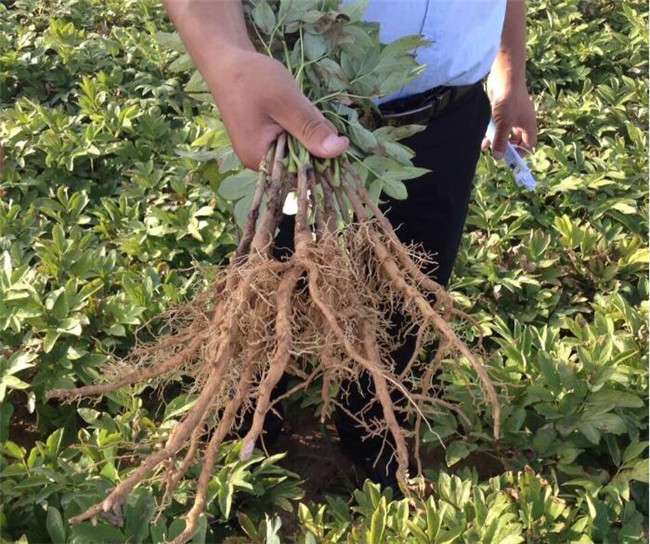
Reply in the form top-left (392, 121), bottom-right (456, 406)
top-left (49, 134), bottom-right (501, 544)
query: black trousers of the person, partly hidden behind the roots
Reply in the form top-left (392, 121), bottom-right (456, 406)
top-left (267, 86), bottom-right (490, 457)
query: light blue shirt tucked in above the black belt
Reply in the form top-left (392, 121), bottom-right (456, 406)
top-left (364, 0), bottom-right (506, 98)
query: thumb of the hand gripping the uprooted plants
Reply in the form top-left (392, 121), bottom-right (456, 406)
top-left (274, 92), bottom-right (349, 159)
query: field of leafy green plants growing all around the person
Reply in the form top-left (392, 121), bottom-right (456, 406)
top-left (0, 0), bottom-right (649, 544)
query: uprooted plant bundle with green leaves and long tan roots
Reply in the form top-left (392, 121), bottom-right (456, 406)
top-left (49, 0), bottom-right (500, 543)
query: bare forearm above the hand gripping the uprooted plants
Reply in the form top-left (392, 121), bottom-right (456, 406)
top-left (162, 0), bottom-right (254, 79)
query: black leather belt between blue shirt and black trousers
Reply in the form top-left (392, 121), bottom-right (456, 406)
top-left (376, 82), bottom-right (482, 127)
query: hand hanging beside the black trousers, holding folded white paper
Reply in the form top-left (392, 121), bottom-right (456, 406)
top-left (482, 71), bottom-right (537, 159)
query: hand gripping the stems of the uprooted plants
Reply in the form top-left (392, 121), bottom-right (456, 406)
top-left (206, 49), bottom-right (349, 170)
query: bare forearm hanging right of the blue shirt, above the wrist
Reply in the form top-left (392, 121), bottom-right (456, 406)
top-left (492, 0), bottom-right (526, 86)
